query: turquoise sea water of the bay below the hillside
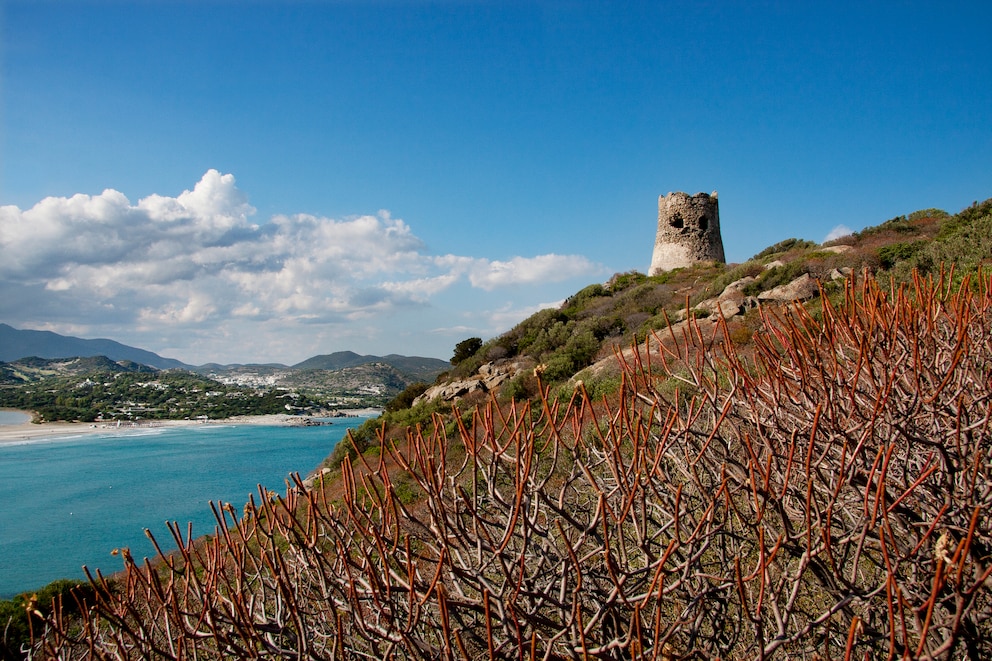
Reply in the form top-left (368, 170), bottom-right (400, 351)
top-left (0, 418), bottom-right (364, 598)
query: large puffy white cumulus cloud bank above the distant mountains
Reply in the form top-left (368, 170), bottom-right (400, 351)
top-left (0, 170), bottom-right (601, 358)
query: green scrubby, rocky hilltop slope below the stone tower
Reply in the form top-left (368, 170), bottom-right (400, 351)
top-left (400, 201), bottom-right (992, 410)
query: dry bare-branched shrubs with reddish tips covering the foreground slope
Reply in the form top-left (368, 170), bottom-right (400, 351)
top-left (36, 275), bottom-right (992, 659)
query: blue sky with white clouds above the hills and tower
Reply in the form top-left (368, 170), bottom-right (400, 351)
top-left (0, 0), bottom-right (992, 363)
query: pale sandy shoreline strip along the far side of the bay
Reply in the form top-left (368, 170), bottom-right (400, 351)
top-left (0, 409), bottom-right (380, 445)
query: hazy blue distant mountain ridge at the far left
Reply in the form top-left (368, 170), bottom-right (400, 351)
top-left (0, 324), bottom-right (190, 370)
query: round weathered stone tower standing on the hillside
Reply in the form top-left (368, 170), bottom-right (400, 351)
top-left (648, 191), bottom-right (726, 275)
